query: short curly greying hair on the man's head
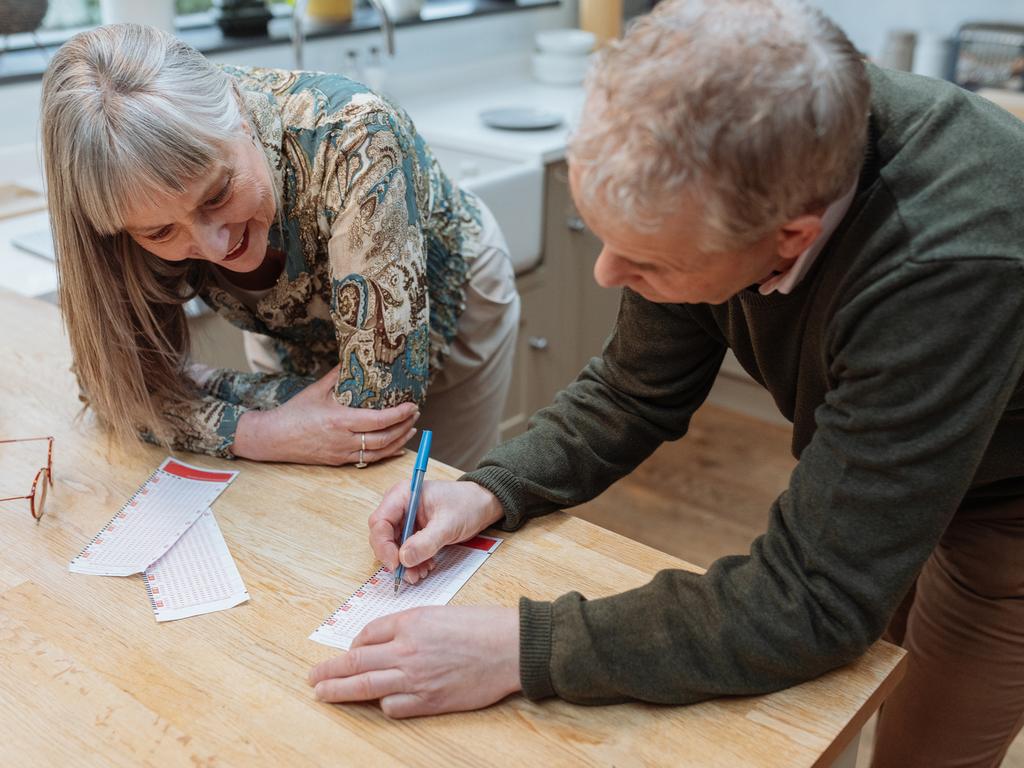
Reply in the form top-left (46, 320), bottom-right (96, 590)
top-left (569, 0), bottom-right (870, 252)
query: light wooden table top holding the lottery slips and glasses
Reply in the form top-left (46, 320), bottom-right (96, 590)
top-left (0, 293), bottom-right (903, 768)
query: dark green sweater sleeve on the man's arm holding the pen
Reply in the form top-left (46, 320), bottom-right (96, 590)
top-left (462, 289), bottom-right (725, 529)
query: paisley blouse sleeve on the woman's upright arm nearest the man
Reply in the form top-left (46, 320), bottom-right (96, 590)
top-left (328, 111), bottom-right (430, 408)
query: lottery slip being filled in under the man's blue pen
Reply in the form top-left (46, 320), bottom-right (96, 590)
top-left (309, 536), bottom-right (502, 650)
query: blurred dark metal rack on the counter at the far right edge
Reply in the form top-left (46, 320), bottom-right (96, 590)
top-left (953, 23), bottom-right (1024, 91)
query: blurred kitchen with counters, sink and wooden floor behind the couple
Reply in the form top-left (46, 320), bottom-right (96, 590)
top-left (0, 0), bottom-right (1024, 768)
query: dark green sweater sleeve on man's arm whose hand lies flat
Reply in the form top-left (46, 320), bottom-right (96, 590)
top-left (510, 259), bottom-right (1024, 703)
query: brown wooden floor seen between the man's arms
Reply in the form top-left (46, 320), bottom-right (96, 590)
top-left (572, 404), bottom-right (1024, 768)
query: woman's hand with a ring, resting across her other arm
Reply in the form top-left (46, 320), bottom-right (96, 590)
top-left (231, 367), bottom-right (420, 466)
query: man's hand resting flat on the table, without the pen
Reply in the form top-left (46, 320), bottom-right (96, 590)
top-left (309, 606), bottom-right (521, 718)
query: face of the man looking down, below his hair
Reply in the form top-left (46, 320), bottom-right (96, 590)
top-left (569, 163), bottom-right (794, 304)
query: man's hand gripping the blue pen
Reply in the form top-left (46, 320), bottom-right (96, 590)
top-left (370, 480), bottom-right (505, 584)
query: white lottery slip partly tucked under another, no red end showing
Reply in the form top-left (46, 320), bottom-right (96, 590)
top-left (142, 509), bottom-right (249, 622)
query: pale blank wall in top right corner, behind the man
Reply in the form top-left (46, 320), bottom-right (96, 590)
top-left (811, 0), bottom-right (1024, 56)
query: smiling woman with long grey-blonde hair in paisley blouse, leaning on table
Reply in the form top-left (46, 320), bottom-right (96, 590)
top-left (42, 25), bottom-right (518, 466)
